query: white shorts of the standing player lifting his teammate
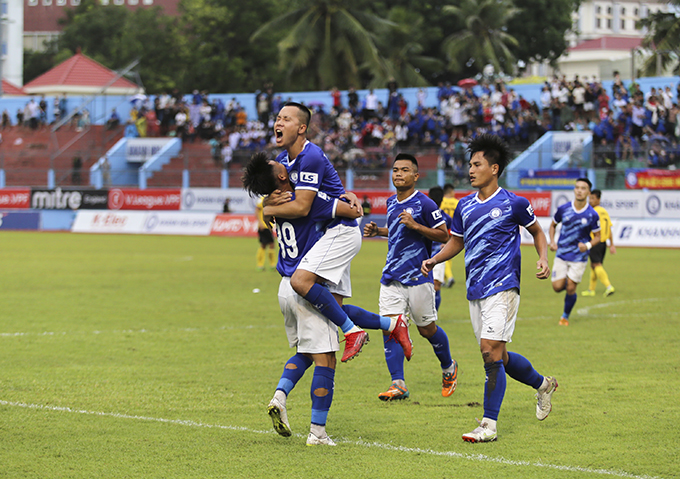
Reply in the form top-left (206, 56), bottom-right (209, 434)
top-left (279, 277), bottom-right (340, 354)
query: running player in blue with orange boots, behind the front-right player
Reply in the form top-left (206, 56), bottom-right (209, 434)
top-left (364, 153), bottom-right (458, 401)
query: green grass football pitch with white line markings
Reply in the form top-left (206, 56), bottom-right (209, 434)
top-left (0, 232), bottom-right (680, 479)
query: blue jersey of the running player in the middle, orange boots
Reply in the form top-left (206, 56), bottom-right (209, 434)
top-left (380, 191), bottom-right (444, 286)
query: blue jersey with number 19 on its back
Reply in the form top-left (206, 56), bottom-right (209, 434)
top-left (276, 193), bottom-right (338, 276)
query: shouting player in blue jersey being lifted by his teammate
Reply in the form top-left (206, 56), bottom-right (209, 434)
top-left (264, 103), bottom-right (368, 362)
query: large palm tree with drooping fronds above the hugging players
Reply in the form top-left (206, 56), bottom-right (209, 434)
top-left (251, 0), bottom-right (389, 90)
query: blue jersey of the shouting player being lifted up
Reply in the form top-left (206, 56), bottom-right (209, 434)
top-left (276, 141), bottom-right (359, 228)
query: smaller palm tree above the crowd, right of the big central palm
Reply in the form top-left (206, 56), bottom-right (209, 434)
top-left (442, 0), bottom-right (519, 76)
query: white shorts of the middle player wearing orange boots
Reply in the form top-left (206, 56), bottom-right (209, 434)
top-left (379, 281), bottom-right (437, 328)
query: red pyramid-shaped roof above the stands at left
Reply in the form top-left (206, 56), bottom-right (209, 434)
top-left (24, 53), bottom-right (137, 91)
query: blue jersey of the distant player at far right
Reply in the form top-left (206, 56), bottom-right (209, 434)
top-left (553, 203), bottom-right (600, 263)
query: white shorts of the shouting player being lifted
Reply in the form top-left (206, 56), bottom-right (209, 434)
top-left (298, 224), bottom-right (361, 298)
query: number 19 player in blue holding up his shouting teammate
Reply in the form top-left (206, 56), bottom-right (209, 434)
top-left (243, 154), bottom-right (411, 445)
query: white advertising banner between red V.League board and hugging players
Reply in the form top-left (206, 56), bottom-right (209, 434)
top-left (180, 188), bottom-right (257, 214)
